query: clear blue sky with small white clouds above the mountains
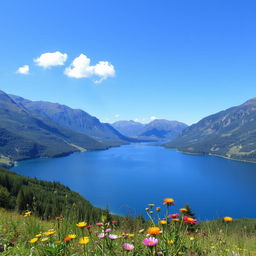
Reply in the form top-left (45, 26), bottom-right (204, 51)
top-left (0, 0), bottom-right (256, 124)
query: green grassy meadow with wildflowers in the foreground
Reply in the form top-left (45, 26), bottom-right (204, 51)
top-left (0, 206), bottom-right (256, 256)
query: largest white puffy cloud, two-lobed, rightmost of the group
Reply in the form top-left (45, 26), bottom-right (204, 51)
top-left (64, 54), bottom-right (115, 83)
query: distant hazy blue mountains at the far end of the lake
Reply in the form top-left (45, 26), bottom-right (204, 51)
top-left (112, 119), bottom-right (187, 140)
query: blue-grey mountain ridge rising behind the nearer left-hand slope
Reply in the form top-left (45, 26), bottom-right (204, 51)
top-left (9, 95), bottom-right (133, 145)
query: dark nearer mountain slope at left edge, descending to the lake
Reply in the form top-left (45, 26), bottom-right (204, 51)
top-left (0, 91), bottom-right (107, 166)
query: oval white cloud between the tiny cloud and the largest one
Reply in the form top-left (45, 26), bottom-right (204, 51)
top-left (34, 51), bottom-right (68, 68)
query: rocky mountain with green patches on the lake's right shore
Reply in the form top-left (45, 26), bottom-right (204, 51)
top-left (166, 98), bottom-right (256, 161)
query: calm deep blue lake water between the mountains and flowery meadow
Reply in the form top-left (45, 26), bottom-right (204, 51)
top-left (12, 144), bottom-right (256, 219)
